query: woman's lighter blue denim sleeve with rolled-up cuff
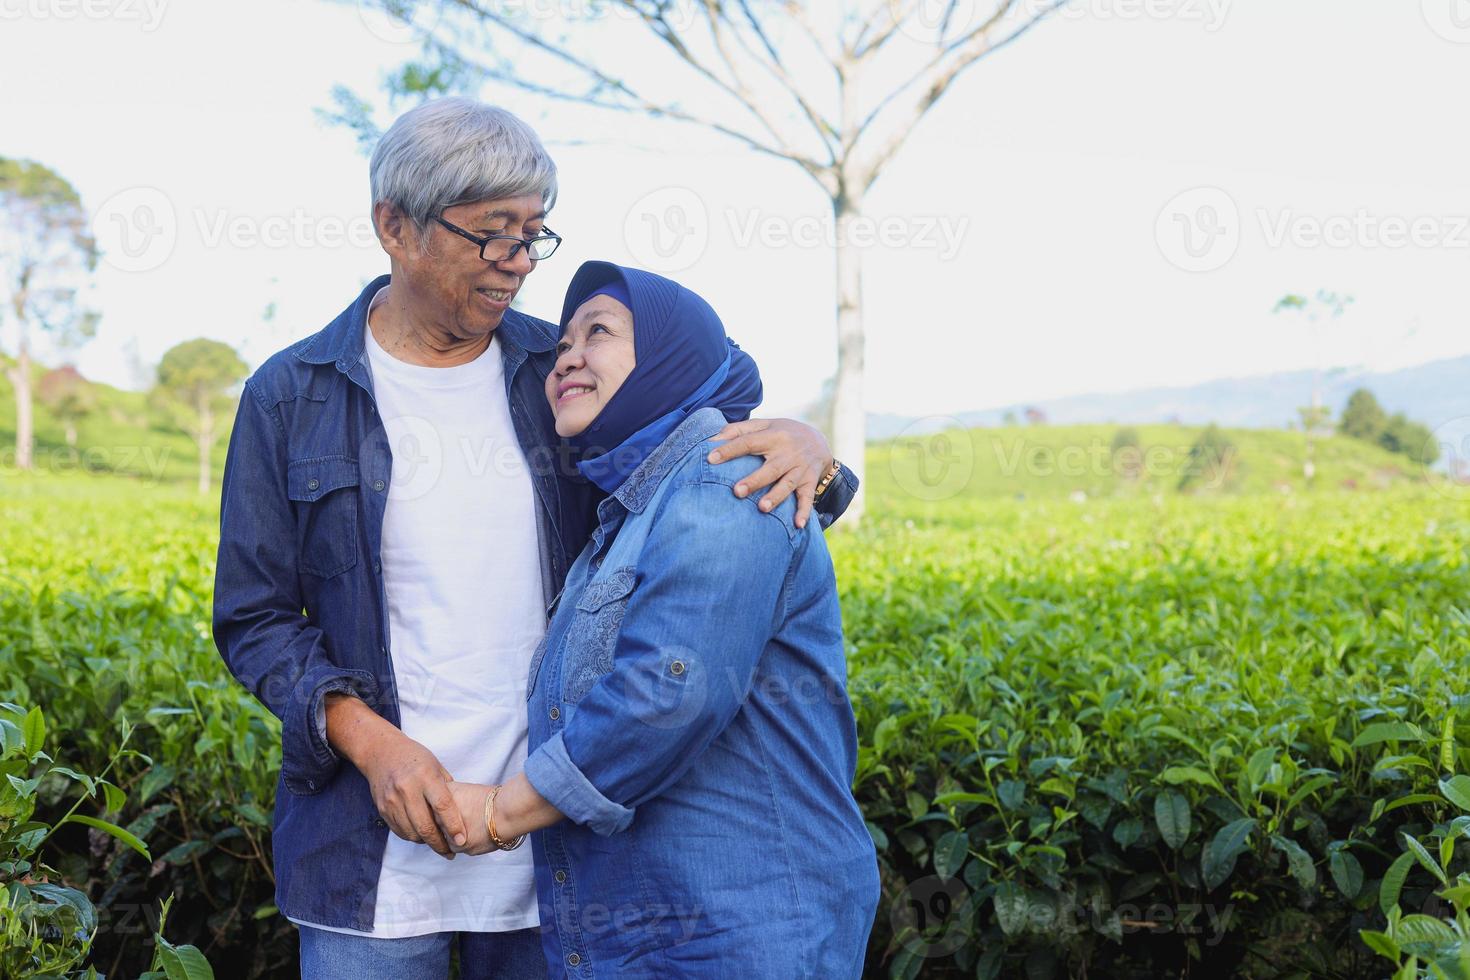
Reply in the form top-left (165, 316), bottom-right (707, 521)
top-left (525, 483), bottom-right (803, 835)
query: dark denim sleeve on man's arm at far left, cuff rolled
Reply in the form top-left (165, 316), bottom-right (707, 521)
top-left (213, 382), bottom-right (378, 795)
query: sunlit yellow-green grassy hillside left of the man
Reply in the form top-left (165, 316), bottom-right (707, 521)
top-left (0, 359), bottom-right (226, 483)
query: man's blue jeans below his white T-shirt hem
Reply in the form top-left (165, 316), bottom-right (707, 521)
top-left (297, 926), bottom-right (547, 980)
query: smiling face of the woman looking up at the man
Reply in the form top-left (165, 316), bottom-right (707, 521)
top-left (547, 294), bottom-right (637, 438)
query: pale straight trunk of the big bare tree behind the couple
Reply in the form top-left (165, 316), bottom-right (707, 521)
top-left (832, 194), bottom-right (867, 527)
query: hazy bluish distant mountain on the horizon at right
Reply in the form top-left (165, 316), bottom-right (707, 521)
top-left (867, 357), bottom-right (1470, 458)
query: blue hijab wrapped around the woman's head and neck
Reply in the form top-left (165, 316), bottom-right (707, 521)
top-left (562, 262), bottom-right (761, 494)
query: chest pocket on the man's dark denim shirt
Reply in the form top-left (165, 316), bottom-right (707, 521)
top-left (285, 455), bottom-right (362, 579)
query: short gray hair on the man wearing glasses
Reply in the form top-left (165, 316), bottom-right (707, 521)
top-left (369, 96), bottom-right (556, 235)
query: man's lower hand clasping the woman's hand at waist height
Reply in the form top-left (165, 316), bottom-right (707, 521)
top-left (326, 693), bottom-right (469, 860)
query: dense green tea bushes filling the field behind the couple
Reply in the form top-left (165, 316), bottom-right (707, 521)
top-left (0, 479), bottom-right (1470, 977)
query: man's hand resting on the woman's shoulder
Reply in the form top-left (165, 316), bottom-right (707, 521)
top-left (707, 419), bottom-right (832, 527)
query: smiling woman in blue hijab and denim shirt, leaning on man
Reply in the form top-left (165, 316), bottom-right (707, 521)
top-left (454, 262), bottom-right (879, 980)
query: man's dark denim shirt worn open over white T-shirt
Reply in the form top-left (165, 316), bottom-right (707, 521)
top-left (215, 276), bottom-right (857, 932)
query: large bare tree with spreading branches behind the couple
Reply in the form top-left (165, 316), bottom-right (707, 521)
top-left (346, 0), bottom-right (1066, 525)
